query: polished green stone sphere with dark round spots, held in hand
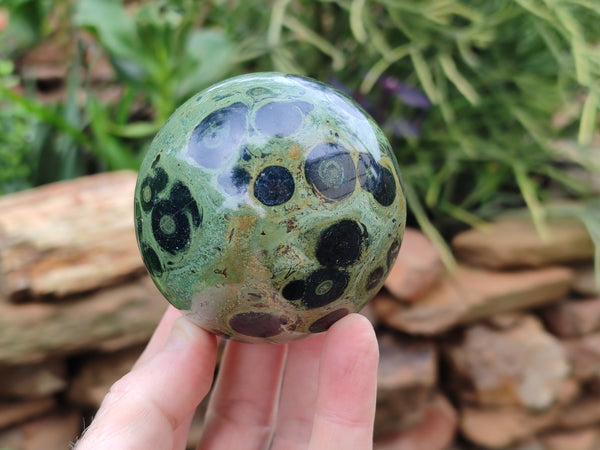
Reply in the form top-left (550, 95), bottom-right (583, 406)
top-left (135, 73), bottom-right (406, 343)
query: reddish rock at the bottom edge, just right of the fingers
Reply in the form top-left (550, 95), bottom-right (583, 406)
top-left (373, 394), bottom-right (458, 450)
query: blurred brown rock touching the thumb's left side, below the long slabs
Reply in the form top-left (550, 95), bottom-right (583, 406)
top-left (68, 346), bottom-right (143, 409)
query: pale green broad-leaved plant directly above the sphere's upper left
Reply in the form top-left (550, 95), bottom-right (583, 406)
top-left (74, 0), bottom-right (234, 125)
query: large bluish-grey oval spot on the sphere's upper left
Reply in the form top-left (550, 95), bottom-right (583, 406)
top-left (187, 102), bottom-right (248, 169)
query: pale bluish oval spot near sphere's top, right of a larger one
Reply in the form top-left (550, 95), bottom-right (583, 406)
top-left (254, 102), bottom-right (312, 137)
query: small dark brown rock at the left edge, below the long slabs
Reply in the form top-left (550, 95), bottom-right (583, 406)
top-left (0, 360), bottom-right (67, 398)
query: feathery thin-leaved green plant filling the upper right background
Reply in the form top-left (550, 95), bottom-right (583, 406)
top-left (258, 0), bottom-right (600, 264)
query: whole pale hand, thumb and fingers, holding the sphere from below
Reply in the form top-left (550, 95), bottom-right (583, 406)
top-left (76, 307), bottom-right (379, 450)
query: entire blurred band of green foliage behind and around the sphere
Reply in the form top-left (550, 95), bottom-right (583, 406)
top-left (0, 0), bottom-right (600, 264)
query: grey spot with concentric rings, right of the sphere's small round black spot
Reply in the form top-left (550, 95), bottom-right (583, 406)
top-left (304, 143), bottom-right (356, 201)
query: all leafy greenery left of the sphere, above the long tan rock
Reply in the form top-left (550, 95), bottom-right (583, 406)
top-left (0, 0), bottom-right (239, 192)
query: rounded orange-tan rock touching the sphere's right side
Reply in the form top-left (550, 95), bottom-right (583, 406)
top-left (385, 228), bottom-right (444, 302)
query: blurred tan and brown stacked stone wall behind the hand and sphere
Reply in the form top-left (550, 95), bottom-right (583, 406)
top-left (0, 172), bottom-right (600, 450)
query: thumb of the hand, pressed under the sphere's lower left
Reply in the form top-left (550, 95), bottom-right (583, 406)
top-left (76, 317), bottom-right (217, 450)
